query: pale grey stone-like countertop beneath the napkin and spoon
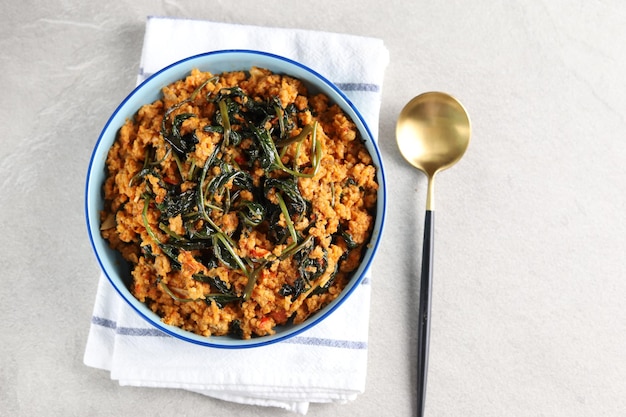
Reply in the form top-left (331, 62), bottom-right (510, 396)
top-left (0, 0), bottom-right (626, 417)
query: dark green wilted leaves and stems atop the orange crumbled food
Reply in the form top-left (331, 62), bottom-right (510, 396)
top-left (132, 75), bottom-right (351, 307)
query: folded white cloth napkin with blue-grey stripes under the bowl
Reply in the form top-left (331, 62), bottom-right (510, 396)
top-left (84, 17), bottom-right (389, 414)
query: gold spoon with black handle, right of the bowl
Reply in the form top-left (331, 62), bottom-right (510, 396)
top-left (396, 92), bottom-right (471, 417)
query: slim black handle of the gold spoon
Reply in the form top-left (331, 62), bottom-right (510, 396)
top-left (417, 210), bottom-right (435, 417)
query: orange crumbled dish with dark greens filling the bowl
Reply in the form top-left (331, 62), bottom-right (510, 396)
top-left (101, 68), bottom-right (378, 339)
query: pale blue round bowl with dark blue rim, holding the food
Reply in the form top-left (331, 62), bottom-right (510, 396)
top-left (85, 50), bottom-right (386, 349)
